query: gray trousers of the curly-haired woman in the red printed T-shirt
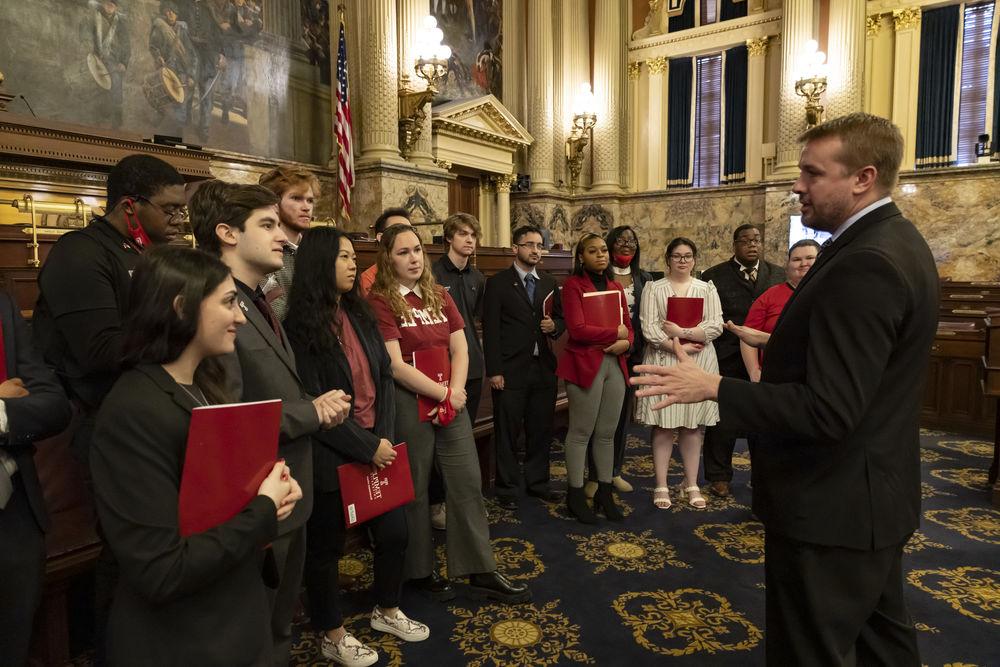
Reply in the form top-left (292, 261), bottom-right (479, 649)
top-left (396, 385), bottom-right (497, 579)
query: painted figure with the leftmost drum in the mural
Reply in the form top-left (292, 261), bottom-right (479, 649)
top-left (87, 0), bottom-right (132, 128)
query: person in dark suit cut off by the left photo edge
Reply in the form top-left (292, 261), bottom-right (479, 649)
top-left (0, 293), bottom-right (70, 665)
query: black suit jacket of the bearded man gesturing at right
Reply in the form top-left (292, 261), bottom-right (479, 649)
top-left (719, 204), bottom-right (938, 549)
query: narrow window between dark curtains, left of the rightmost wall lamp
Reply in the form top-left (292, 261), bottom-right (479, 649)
top-left (694, 54), bottom-right (722, 187)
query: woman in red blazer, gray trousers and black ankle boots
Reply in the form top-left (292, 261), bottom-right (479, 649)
top-left (556, 234), bottom-right (633, 523)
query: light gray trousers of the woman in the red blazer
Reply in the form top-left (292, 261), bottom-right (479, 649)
top-left (566, 354), bottom-right (625, 488)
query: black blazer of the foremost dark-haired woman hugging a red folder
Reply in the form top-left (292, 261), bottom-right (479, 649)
top-left (90, 365), bottom-right (278, 667)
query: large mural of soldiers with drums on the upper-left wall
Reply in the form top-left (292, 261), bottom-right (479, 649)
top-left (0, 0), bottom-right (316, 157)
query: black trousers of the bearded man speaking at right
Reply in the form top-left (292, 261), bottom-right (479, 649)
top-left (764, 531), bottom-right (920, 667)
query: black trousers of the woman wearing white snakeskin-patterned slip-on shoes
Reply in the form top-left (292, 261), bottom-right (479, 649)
top-left (305, 489), bottom-right (408, 632)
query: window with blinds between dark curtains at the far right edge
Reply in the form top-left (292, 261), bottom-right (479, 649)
top-left (957, 2), bottom-right (997, 164)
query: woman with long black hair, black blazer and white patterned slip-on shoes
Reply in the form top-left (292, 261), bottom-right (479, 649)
top-left (285, 227), bottom-right (430, 665)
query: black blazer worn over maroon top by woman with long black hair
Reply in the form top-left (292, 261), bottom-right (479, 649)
top-left (288, 312), bottom-right (396, 492)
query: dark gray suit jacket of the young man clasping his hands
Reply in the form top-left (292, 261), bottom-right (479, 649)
top-left (221, 285), bottom-right (320, 535)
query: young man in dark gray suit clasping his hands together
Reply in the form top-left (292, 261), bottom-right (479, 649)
top-left (191, 180), bottom-right (350, 666)
